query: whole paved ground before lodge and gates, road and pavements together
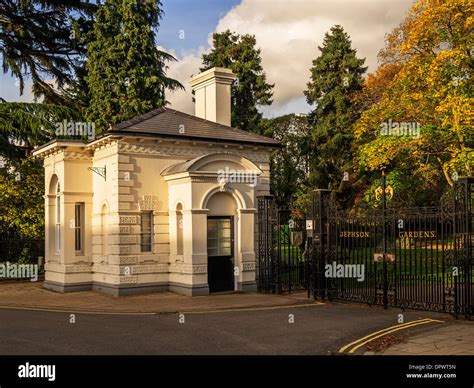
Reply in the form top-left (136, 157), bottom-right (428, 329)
top-left (0, 282), bottom-right (474, 356)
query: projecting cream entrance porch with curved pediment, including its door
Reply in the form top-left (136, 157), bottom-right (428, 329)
top-left (161, 153), bottom-right (262, 295)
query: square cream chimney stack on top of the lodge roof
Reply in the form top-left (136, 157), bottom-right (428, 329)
top-left (189, 67), bottom-right (237, 126)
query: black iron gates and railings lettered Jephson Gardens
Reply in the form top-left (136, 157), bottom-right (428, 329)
top-left (257, 178), bottom-right (474, 318)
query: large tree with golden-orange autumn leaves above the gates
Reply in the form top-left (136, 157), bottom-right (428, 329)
top-left (354, 0), bottom-right (474, 204)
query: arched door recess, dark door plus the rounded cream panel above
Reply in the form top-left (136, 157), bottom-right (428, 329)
top-left (207, 192), bottom-right (238, 292)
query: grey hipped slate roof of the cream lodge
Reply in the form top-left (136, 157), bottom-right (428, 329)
top-left (109, 108), bottom-right (280, 147)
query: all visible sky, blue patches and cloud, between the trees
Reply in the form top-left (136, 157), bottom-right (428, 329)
top-left (0, 0), bottom-right (413, 117)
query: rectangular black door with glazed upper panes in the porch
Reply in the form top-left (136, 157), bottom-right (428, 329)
top-left (207, 217), bottom-right (234, 292)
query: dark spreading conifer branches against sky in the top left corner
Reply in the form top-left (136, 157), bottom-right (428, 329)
top-left (0, 0), bottom-right (97, 105)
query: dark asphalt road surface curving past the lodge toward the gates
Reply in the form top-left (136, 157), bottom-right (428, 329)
top-left (0, 303), bottom-right (451, 355)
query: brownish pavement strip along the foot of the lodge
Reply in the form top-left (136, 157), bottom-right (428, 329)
top-left (0, 282), bottom-right (313, 314)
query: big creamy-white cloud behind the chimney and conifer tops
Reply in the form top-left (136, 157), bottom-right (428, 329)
top-left (168, 0), bottom-right (413, 116)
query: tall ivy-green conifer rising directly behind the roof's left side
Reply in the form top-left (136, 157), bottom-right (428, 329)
top-left (85, 0), bottom-right (182, 133)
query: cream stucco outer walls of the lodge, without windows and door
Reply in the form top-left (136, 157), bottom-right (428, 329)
top-left (36, 136), bottom-right (271, 294)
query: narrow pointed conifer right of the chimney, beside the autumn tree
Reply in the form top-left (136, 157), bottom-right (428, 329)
top-left (305, 26), bottom-right (367, 189)
